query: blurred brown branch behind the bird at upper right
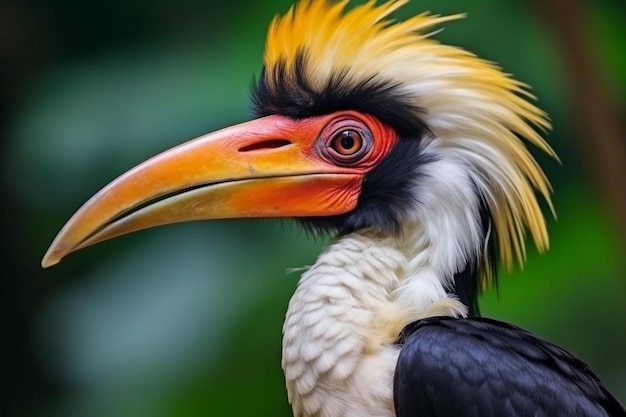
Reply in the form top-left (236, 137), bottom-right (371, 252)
top-left (534, 0), bottom-right (626, 250)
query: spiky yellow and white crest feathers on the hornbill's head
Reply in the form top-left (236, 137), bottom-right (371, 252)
top-left (251, 0), bottom-right (555, 282)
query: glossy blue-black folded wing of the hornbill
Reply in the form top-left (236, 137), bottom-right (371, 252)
top-left (394, 317), bottom-right (626, 417)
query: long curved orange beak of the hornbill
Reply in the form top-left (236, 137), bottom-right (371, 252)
top-left (42, 115), bottom-right (364, 267)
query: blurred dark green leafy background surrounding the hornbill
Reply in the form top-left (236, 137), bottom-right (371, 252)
top-left (0, 0), bottom-right (626, 417)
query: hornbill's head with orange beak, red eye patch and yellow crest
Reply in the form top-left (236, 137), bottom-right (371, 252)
top-left (42, 0), bottom-right (554, 290)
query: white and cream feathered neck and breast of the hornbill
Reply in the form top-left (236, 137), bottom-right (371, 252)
top-left (282, 154), bottom-right (484, 417)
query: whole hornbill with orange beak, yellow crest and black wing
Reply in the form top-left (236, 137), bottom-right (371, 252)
top-left (42, 0), bottom-right (626, 417)
